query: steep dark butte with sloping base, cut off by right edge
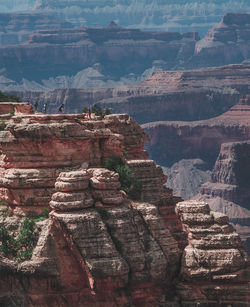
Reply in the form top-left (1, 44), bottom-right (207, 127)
top-left (197, 141), bottom-right (250, 249)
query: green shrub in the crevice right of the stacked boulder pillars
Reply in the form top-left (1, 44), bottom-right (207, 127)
top-left (103, 156), bottom-right (142, 200)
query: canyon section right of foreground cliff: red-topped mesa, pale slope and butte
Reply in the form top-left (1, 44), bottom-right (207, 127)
top-left (142, 95), bottom-right (250, 253)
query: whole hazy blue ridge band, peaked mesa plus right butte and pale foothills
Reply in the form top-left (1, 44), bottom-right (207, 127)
top-left (0, 13), bottom-right (250, 92)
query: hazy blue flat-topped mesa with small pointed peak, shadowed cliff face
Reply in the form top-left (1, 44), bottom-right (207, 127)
top-left (0, 25), bottom-right (197, 84)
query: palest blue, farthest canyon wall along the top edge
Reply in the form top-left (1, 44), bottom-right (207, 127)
top-left (0, 0), bottom-right (249, 37)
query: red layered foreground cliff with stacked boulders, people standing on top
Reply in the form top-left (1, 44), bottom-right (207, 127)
top-left (0, 103), bottom-right (247, 307)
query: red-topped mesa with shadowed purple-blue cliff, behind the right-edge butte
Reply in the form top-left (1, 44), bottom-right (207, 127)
top-left (142, 96), bottom-right (250, 168)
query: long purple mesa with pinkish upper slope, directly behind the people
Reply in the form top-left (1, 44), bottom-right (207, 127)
top-left (14, 65), bottom-right (250, 123)
